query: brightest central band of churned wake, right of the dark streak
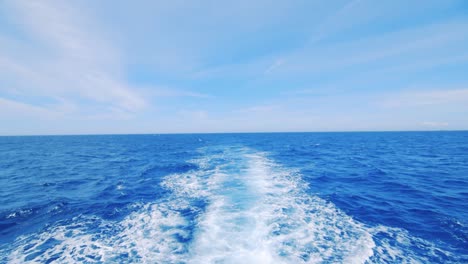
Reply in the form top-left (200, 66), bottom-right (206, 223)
top-left (166, 149), bottom-right (374, 263)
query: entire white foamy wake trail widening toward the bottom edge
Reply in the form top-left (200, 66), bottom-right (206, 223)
top-left (4, 147), bottom-right (458, 263)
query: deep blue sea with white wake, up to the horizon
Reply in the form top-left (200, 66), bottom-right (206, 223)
top-left (0, 132), bottom-right (468, 263)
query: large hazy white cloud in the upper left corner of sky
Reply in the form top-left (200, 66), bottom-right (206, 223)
top-left (0, 0), bottom-right (147, 112)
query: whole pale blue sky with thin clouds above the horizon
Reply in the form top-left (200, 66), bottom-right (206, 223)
top-left (0, 0), bottom-right (468, 135)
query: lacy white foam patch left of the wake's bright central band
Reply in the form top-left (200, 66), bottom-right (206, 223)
top-left (8, 201), bottom-right (190, 263)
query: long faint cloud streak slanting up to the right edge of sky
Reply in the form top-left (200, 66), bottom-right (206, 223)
top-left (276, 20), bottom-right (468, 76)
